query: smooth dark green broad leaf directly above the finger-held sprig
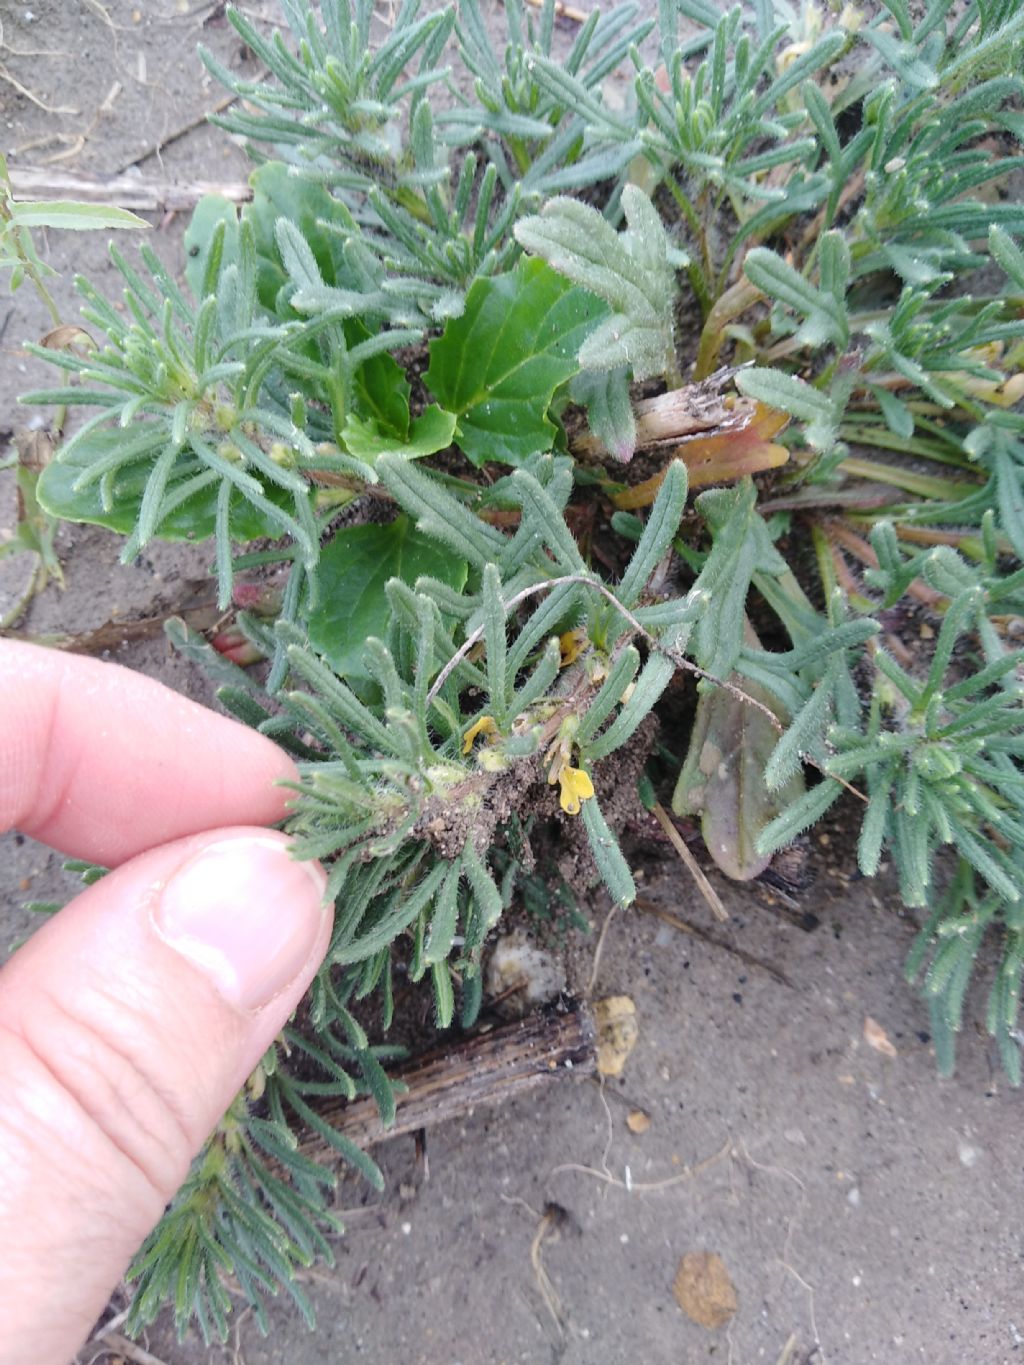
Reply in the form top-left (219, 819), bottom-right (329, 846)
top-left (309, 516), bottom-right (467, 678)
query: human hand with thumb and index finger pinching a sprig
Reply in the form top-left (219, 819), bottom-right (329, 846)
top-left (0, 642), bottom-right (332, 1365)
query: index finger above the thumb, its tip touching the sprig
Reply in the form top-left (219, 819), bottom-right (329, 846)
top-left (0, 640), bottom-right (296, 867)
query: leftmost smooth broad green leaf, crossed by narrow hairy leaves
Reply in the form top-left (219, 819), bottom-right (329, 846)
top-left (37, 430), bottom-right (300, 541)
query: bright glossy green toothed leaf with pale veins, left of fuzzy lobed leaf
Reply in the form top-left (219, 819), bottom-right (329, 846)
top-left (425, 259), bottom-right (605, 464)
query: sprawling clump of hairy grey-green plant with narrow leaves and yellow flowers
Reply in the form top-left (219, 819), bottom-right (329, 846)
top-left (13, 0), bottom-right (1024, 1335)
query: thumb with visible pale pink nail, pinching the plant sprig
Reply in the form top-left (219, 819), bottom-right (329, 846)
top-left (0, 829), bottom-right (330, 1365)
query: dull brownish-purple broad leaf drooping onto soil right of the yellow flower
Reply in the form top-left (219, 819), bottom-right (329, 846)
top-left (672, 673), bottom-right (804, 882)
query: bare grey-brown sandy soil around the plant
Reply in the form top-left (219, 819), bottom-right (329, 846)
top-left (0, 0), bottom-right (1024, 1365)
